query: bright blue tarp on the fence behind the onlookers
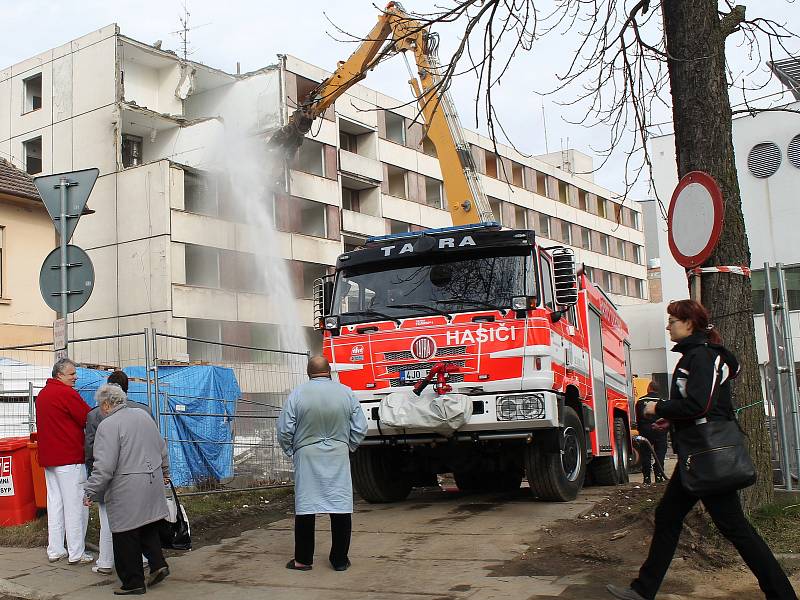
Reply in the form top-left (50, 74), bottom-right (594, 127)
top-left (75, 365), bottom-right (241, 486)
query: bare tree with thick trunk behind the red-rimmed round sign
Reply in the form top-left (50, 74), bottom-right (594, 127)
top-left (390, 0), bottom-right (796, 509)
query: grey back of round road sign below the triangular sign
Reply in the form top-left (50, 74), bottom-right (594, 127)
top-left (39, 244), bottom-right (94, 312)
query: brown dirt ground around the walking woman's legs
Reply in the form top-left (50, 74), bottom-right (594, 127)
top-left (491, 484), bottom-right (800, 600)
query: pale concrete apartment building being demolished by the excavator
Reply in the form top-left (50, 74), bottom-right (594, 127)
top-left (0, 25), bottom-right (647, 353)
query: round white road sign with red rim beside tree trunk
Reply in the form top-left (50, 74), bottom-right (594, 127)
top-left (667, 171), bottom-right (723, 269)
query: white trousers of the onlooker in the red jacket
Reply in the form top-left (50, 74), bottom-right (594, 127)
top-left (44, 464), bottom-right (89, 561)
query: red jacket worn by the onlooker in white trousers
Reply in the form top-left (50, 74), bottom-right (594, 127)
top-left (36, 379), bottom-right (91, 467)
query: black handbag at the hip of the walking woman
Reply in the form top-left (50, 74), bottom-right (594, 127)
top-left (675, 419), bottom-right (757, 497)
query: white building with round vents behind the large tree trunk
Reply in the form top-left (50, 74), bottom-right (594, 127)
top-left (651, 58), bottom-right (800, 382)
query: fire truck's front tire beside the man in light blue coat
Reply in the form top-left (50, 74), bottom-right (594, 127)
top-left (350, 446), bottom-right (411, 503)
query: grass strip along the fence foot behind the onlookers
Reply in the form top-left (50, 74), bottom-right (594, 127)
top-left (0, 487), bottom-right (293, 548)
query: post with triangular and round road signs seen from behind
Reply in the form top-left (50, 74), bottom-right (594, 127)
top-left (33, 169), bottom-right (100, 354)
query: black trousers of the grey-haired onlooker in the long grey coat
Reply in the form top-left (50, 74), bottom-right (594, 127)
top-left (111, 521), bottom-right (167, 590)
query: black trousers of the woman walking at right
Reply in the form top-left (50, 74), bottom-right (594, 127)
top-left (631, 469), bottom-right (797, 600)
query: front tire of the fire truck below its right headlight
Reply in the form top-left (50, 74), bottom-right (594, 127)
top-left (525, 406), bottom-right (586, 502)
